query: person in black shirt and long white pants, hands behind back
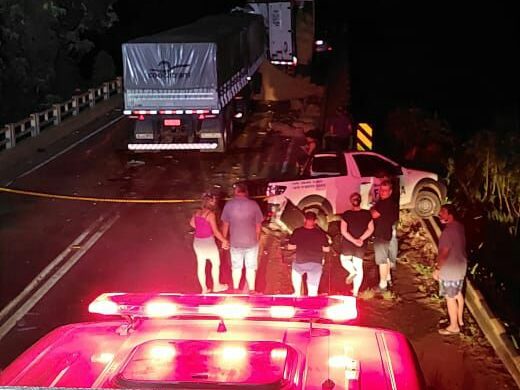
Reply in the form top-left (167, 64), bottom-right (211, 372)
top-left (340, 192), bottom-right (374, 297)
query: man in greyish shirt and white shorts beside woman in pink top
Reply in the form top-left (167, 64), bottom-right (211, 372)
top-left (222, 183), bottom-right (264, 291)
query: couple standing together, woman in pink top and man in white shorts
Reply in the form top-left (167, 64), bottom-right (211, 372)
top-left (190, 183), bottom-right (263, 294)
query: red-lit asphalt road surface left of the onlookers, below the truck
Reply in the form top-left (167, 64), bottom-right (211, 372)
top-left (0, 106), bottom-right (300, 366)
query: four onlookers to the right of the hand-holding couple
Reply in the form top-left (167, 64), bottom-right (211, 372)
top-left (288, 178), bottom-right (467, 335)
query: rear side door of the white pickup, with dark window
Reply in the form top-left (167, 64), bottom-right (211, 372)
top-left (310, 153), bottom-right (360, 214)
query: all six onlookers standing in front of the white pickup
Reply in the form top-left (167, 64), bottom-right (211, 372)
top-left (190, 177), bottom-right (467, 335)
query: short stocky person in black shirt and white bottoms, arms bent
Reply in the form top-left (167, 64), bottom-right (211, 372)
top-left (287, 211), bottom-right (330, 296)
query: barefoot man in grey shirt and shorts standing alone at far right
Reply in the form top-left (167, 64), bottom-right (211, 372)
top-left (433, 204), bottom-right (468, 335)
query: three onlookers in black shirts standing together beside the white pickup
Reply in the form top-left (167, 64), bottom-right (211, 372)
top-left (288, 179), bottom-right (399, 296)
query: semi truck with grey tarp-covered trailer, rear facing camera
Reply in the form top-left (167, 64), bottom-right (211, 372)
top-left (122, 12), bottom-right (265, 152)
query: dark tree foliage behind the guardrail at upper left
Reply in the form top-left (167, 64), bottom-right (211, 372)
top-left (0, 0), bottom-right (117, 123)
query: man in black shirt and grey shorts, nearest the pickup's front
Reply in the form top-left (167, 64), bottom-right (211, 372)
top-left (370, 180), bottom-right (399, 291)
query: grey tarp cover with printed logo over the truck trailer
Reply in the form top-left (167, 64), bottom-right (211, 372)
top-left (123, 13), bottom-right (264, 90)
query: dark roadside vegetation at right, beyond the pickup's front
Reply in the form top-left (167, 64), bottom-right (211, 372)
top-left (386, 108), bottom-right (520, 345)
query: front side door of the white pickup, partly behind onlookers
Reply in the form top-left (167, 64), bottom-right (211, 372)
top-left (351, 152), bottom-right (403, 208)
